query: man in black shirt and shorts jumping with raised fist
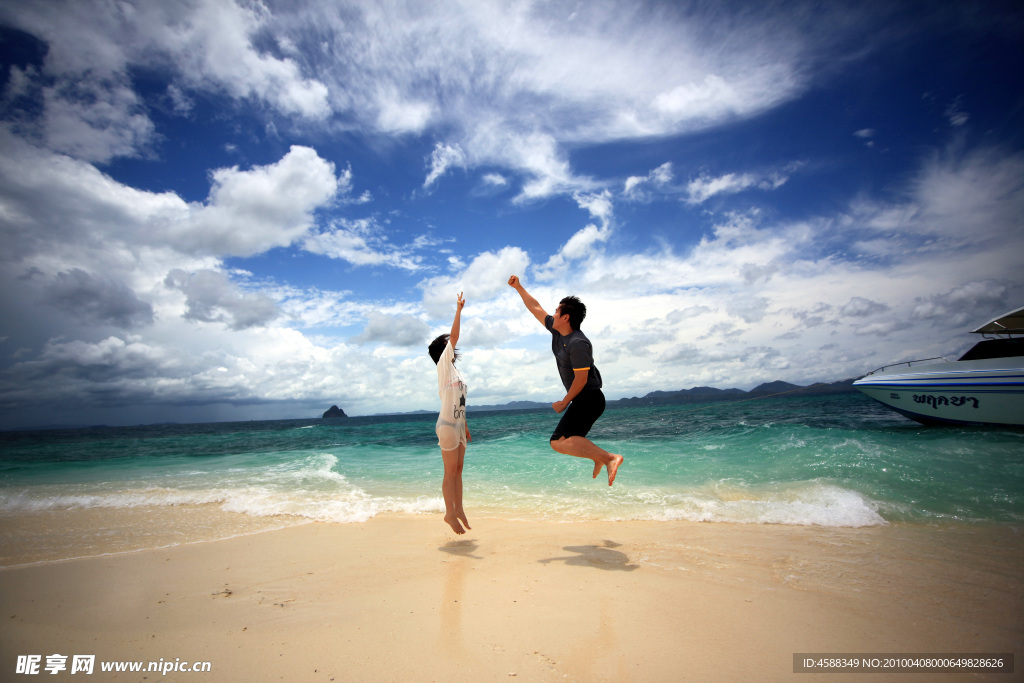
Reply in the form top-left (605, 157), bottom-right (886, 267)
top-left (509, 275), bottom-right (623, 486)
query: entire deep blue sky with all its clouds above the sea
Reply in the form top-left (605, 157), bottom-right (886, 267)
top-left (0, 0), bottom-right (1024, 427)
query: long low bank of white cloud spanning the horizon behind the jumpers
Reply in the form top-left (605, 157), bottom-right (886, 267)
top-left (8, 134), bottom-right (1024, 421)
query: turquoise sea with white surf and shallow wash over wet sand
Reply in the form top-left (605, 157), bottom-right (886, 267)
top-left (0, 394), bottom-right (1024, 566)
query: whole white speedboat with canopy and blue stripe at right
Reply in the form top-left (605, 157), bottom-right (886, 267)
top-left (853, 308), bottom-right (1024, 426)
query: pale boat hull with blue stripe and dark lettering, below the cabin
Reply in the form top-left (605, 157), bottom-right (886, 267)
top-left (853, 357), bottom-right (1024, 427)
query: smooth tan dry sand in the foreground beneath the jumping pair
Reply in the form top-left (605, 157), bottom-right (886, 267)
top-left (0, 515), bottom-right (1024, 681)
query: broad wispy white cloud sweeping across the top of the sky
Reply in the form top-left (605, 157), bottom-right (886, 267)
top-left (7, 0), bottom-right (831, 201)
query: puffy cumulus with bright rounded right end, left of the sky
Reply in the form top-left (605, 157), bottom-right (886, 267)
top-left (0, 141), bottom-right (348, 258)
